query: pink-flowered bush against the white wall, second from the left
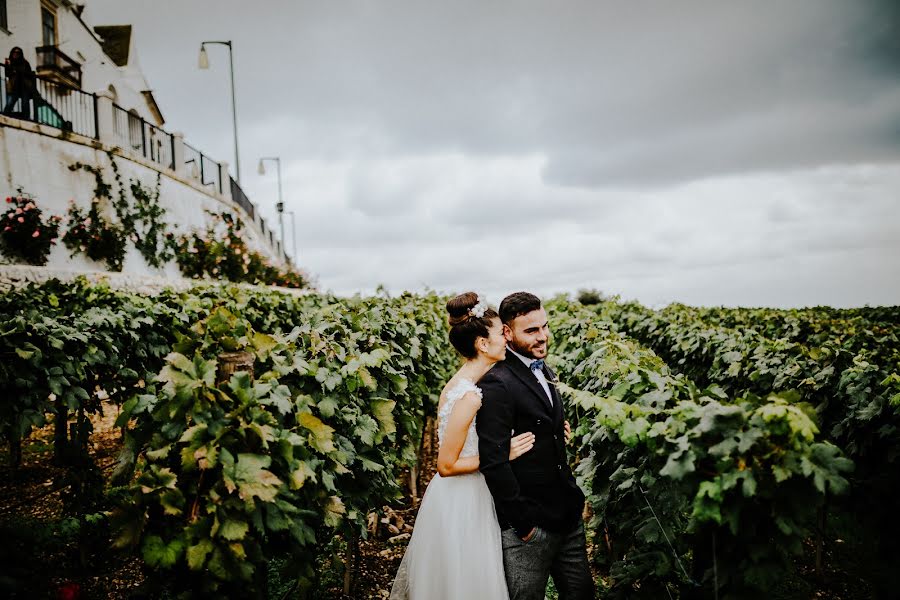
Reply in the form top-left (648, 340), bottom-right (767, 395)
top-left (63, 198), bottom-right (127, 271)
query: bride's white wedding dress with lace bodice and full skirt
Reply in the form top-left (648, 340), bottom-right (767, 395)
top-left (391, 379), bottom-right (509, 600)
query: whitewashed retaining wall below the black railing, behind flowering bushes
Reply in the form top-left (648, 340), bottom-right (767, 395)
top-left (0, 117), bottom-right (283, 278)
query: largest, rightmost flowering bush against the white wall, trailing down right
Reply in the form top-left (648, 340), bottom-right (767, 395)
top-left (175, 211), bottom-right (309, 288)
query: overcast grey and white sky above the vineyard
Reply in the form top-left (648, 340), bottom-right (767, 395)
top-left (85, 0), bottom-right (900, 306)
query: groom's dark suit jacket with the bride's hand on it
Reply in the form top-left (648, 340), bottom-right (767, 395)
top-left (475, 354), bottom-right (584, 537)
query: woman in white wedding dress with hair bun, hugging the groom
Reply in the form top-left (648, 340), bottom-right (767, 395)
top-left (390, 292), bottom-right (534, 600)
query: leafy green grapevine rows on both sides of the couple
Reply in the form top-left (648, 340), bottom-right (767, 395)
top-left (0, 281), bottom-right (900, 599)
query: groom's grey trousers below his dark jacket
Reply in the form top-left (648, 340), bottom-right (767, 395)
top-left (502, 523), bottom-right (594, 600)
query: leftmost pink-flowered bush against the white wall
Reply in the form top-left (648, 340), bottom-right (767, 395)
top-left (0, 194), bottom-right (61, 265)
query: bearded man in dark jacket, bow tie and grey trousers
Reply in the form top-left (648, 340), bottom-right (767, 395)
top-left (475, 292), bottom-right (594, 600)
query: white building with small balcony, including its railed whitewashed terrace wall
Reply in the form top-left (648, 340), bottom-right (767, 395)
top-left (0, 0), bottom-right (288, 276)
